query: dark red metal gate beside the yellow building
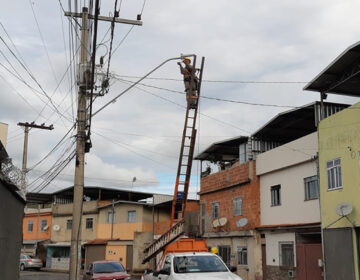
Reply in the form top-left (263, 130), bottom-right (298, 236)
top-left (296, 244), bottom-right (324, 280)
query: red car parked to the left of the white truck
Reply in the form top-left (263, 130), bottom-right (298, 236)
top-left (83, 261), bottom-right (130, 280)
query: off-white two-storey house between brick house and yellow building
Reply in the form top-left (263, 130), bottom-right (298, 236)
top-left (256, 132), bottom-right (323, 280)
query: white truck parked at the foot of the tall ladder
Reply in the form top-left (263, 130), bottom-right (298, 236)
top-left (143, 252), bottom-right (242, 280)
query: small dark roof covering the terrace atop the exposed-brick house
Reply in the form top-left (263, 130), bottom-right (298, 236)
top-left (195, 136), bottom-right (249, 161)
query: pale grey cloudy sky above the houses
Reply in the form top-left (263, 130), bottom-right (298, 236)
top-left (0, 0), bottom-right (360, 197)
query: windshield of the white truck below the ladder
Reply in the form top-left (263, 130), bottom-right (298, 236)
top-left (174, 256), bottom-right (228, 273)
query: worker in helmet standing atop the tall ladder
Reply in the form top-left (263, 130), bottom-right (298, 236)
top-left (178, 57), bottom-right (199, 109)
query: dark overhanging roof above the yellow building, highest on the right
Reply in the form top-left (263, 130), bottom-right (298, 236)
top-left (304, 42), bottom-right (360, 96)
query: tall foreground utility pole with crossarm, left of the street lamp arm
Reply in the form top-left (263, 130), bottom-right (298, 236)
top-left (65, 3), bottom-right (142, 280)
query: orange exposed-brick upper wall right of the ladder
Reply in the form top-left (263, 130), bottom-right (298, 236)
top-left (200, 162), bottom-right (260, 232)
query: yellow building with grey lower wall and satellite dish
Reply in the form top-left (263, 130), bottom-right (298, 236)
top-left (319, 103), bottom-right (360, 280)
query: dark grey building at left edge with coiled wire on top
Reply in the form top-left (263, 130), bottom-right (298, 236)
top-left (0, 137), bottom-right (25, 280)
